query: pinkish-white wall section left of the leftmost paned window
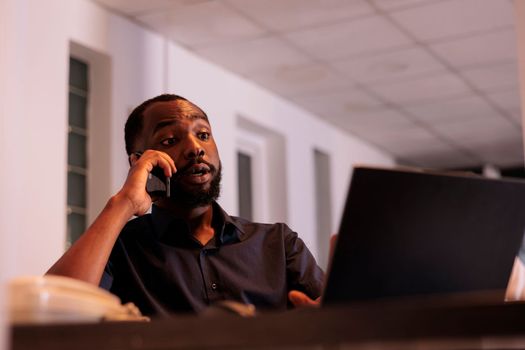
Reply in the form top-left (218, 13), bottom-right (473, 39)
top-left (0, 0), bottom-right (68, 277)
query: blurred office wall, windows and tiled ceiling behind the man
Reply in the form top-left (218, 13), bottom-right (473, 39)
top-left (0, 0), bottom-right (523, 284)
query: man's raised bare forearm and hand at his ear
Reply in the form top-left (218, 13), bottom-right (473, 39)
top-left (46, 150), bottom-right (176, 285)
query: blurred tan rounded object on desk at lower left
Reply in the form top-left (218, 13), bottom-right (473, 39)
top-left (7, 276), bottom-right (149, 324)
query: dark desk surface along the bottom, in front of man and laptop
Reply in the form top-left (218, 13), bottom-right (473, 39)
top-left (11, 297), bottom-right (525, 350)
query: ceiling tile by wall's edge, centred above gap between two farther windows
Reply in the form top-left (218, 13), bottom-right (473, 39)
top-left (250, 64), bottom-right (351, 97)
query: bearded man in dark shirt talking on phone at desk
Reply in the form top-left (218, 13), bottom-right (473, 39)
top-left (48, 95), bottom-right (323, 316)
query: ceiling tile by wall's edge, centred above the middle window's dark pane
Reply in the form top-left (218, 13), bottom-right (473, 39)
top-left (195, 37), bottom-right (311, 75)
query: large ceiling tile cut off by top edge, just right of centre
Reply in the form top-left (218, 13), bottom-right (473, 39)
top-left (227, 0), bottom-right (374, 31)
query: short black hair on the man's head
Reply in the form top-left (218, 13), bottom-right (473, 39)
top-left (124, 94), bottom-right (208, 156)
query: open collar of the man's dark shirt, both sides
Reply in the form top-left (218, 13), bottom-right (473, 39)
top-left (151, 202), bottom-right (245, 244)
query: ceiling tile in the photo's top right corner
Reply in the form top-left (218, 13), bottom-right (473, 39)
top-left (391, 0), bottom-right (514, 40)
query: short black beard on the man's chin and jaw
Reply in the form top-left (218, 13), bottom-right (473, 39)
top-left (170, 162), bottom-right (222, 209)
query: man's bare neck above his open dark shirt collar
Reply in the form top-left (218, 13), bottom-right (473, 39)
top-left (156, 199), bottom-right (215, 245)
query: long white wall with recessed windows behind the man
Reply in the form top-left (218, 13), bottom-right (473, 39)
top-left (0, 0), bottom-right (392, 278)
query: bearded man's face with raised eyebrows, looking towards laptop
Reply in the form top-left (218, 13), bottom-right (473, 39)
top-left (138, 100), bottom-right (221, 207)
